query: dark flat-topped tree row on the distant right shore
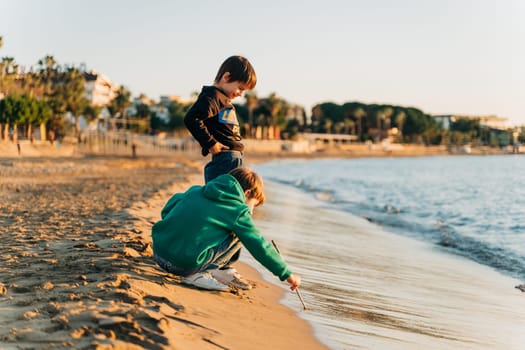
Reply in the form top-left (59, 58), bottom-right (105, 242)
top-left (311, 102), bottom-right (525, 146)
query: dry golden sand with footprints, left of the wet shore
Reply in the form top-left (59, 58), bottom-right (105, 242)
top-left (0, 157), bottom-right (324, 349)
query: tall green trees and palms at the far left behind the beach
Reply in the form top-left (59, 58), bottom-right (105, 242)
top-left (0, 36), bottom-right (135, 139)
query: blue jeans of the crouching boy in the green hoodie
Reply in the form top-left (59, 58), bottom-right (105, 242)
top-left (153, 233), bottom-right (242, 277)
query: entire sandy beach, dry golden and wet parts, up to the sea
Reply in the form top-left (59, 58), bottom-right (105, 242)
top-left (0, 145), bottom-right (525, 350)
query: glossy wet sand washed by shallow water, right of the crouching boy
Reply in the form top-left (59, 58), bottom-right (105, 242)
top-left (249, 179), bottom-right (525, 350)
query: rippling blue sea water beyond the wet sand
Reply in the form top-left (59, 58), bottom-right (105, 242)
top-left (254, 157), bottom-right (525, 278)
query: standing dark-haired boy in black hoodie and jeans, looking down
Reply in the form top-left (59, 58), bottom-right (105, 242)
top-left (184, 56), bottom-right (257, 182)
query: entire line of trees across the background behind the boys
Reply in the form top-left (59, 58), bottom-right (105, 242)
top-left (0, 32), bottom-right (525, 145)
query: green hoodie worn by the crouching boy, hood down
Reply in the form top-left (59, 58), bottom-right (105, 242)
top-left (152, 174), bottom-right (292, 281)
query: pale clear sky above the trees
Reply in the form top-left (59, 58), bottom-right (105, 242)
top-left (0, 0), bottom-right (525, 126)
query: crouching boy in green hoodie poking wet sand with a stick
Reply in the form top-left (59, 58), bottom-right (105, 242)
top-left (152, 168), bottom-right (301, 291)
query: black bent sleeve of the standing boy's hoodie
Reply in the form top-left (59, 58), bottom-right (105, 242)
top-left (184, 95), bottom-right (217, 150)
